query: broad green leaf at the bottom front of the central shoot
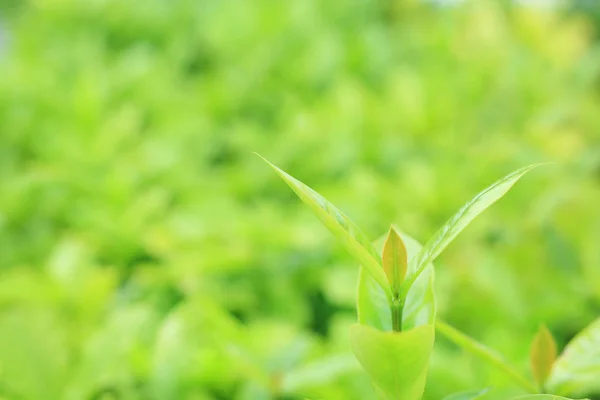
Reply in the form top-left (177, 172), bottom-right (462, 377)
top-left (350, 324), bottom-right (434, 400)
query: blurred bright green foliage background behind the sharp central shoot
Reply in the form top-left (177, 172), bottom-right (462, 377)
top-left (0, 0), bottom-right (600, 400)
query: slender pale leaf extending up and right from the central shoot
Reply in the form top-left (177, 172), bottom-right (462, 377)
top-left (404, 164), bottom-right (542, 291)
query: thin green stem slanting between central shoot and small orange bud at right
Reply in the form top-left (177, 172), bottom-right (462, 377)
top-left (435, 320), bottom-right (538, 393)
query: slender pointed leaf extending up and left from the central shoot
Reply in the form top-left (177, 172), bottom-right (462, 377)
top-left (260, 156), bottom-right (391, 298)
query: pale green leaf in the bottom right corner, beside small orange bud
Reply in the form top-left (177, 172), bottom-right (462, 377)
top-left (546, 318), bottom-right (600, 396)
